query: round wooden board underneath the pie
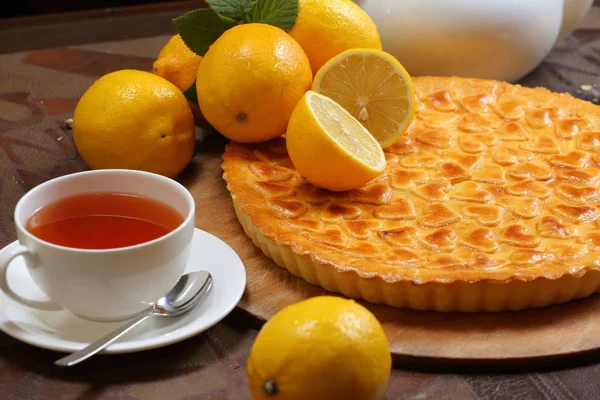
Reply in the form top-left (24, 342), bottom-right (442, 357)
top-left (180, 135), bottom-right (600, 363)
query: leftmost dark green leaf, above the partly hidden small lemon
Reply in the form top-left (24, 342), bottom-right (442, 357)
top-left (173, 8), bottom-right (236, 56)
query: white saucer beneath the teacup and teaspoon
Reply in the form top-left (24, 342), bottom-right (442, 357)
top-left (0, 229), bottom-right (246, 353)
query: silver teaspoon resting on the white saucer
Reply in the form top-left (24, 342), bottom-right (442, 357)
top-left (54, 271), bottom-right (212, 367)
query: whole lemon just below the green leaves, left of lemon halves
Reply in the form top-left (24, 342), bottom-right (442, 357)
top-left (196, 24), bottom-right (312, 143)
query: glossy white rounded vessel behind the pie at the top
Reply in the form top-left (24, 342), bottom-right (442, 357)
top-left (355, 0), bottom-right (593, 82)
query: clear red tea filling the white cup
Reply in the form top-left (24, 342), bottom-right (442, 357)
top-left (25, 192), bottom-right (183, 249)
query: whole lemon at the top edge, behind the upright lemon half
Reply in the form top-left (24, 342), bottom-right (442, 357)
top-left (290, 0), bottom-right (381, 74)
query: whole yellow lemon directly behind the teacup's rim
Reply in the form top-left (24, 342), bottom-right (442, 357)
top-left (73, 70), bottom-right (195, 177)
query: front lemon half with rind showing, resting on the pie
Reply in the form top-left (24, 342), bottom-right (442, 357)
top-left (286, 90), bottom-right (386, 191)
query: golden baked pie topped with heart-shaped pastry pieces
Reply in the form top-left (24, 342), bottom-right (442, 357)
top-left (223, 77), bottom-right (600, 311)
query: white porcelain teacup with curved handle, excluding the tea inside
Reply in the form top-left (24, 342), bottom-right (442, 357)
top-left (0, 169), bottom-right (195, 320)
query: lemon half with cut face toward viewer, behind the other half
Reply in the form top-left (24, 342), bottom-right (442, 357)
top-left (312, 49), bottom-right (415, 148)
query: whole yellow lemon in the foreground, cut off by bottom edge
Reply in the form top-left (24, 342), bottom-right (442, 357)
top-left (247, 296), bottom-right (392, 400)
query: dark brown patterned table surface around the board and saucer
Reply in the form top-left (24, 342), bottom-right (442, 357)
top-left (0, 1), bottom-right (600, 400)
